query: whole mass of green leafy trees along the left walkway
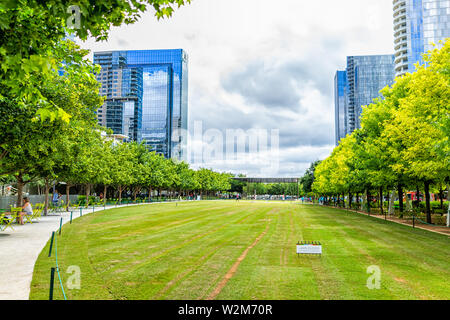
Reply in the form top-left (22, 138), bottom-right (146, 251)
top-left (0, 0), bottom-right (236, 214)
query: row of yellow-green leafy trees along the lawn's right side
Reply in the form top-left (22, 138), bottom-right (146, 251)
top-left (312, 39), bottom-right (450, 223)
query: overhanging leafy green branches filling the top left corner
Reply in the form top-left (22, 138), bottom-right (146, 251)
top-left (0, 0), bottom-right (190, 121)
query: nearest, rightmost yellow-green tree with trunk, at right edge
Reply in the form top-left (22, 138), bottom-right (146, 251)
top-left (383, 41), bottom-right (450, 223)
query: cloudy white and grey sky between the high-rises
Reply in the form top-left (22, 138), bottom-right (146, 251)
top-left (77, 0), bottom-right (393, 177)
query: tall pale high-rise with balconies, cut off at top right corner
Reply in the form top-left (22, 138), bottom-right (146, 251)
top-left (393, 0), bottom-right (450, 76)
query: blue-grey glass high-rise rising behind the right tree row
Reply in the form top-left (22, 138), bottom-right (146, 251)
top-left (335, 54), bottom-right (395, 145)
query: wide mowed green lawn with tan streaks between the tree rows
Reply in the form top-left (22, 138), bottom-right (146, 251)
top-left (30, 201), bottom-right (450, 300)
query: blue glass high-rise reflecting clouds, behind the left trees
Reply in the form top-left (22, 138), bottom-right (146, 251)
top-left (94, 49), bottom-right (188, 160)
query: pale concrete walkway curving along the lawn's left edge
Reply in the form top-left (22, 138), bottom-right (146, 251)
top-left (0, 202), bottom-right (156, 300)
